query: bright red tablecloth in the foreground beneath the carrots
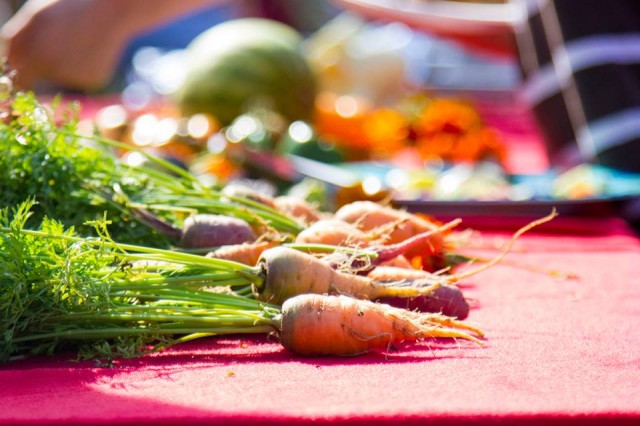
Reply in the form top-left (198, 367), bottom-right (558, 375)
top-left (0, 219), bottom-right (640, 425)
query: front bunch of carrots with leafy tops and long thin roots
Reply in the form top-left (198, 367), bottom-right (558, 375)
top-left (0, 191), bottom-right (552, 362)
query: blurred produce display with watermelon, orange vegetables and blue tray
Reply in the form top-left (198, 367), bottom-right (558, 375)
top-left (96, 14), bottom-right (639, 213)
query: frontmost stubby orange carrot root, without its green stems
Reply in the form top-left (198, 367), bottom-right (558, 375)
top-left (280, 294), bottom-right (483, 356)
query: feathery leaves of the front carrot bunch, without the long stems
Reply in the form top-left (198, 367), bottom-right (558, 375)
top-left (0, 200), bottom-right (113, 361)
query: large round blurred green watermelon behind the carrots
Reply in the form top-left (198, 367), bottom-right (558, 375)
top-left (176, 18), bottom-right (316, 125)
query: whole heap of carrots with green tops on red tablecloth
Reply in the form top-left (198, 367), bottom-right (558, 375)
top-left (0, 80), bottom-right (554, 362)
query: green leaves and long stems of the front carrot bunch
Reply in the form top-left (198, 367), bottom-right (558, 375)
top-left (0, 199), bottom-right (278, 363)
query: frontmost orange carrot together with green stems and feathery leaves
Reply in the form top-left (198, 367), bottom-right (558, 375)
top-left (0, 203), bottom-right (482, 362)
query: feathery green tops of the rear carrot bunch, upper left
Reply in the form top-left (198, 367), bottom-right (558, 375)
top-left (0, 92), bottom-right (168, 246)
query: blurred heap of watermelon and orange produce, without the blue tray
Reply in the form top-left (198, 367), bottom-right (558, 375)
top-left (88, 15), bottom-right (505, 204)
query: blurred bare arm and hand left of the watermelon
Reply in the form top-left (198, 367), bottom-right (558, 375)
top-left (2, 0), bottom-right (229, 90)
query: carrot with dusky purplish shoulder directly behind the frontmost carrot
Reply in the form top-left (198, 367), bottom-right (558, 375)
top-left (254, 246), bottom-right (439, 304)
